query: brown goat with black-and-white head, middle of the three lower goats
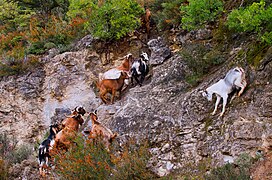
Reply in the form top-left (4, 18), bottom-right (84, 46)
top-left (55, 107), bottom-right (86, 150)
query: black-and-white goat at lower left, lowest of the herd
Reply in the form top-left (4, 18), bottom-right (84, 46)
top-left (38, 124), bottom-right (60, 176)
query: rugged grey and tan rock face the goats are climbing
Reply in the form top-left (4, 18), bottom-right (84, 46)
top-left (0, 34), bottom-right (272, 176)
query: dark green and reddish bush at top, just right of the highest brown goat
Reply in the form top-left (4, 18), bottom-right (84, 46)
top-left (150, 0), bottom-right (185, 30)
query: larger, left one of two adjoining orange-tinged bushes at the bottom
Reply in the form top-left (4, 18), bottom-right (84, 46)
top-left (55, 137), bottom-right (112, 179)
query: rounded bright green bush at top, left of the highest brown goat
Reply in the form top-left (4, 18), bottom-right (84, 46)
top-left (86, 0), bottom-right (143, 41)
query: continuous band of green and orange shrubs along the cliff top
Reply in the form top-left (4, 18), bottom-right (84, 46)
top-left (0, 0), bottom-right (272, 76)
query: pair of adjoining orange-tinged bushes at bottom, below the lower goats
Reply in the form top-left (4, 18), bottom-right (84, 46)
top-left (55, 137), bottom-right (154, 179)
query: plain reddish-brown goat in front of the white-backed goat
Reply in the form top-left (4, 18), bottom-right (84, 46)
top-left (96, 72), bottom-right (129, 104)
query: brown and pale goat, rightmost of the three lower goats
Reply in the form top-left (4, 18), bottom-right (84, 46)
top-left (88, 111), bottom-right (118, 150)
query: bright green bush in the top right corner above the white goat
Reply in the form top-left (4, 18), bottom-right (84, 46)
top-left (226, 0), bottom-right (272, 45)
